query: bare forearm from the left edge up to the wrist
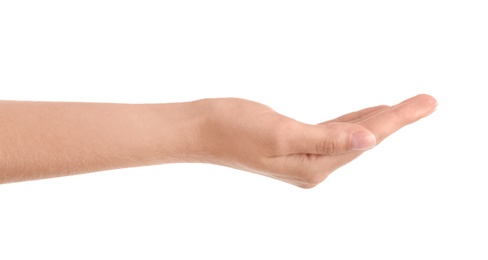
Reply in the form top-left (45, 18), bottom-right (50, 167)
top-left (0, 101), bottom-right (201, 183)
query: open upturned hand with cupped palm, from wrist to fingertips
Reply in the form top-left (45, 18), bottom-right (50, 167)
top-left (197, 94), bottom-right (437, 188)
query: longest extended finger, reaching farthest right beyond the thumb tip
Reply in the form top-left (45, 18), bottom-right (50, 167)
top-left (357, 94), bottom-right (437, 143)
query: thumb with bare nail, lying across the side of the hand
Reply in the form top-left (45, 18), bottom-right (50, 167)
top-left (292, 123), bottom-right (376, 156)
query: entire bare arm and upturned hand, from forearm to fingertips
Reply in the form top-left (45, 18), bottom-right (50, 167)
top-left (0, 94), bottom-right (437, 188)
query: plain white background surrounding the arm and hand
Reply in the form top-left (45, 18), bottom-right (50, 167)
top-left (0, 0), bottom-right (488, 259)
